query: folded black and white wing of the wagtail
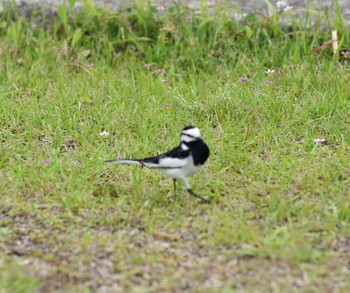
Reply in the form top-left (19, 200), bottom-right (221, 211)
top-left (141, 146), bottom-right (190, 169)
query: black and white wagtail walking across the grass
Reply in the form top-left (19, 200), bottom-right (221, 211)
top-left (106, 126), bottom-right (210, 203)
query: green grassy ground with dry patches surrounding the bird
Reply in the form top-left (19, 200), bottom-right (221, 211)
top-left (0, 2), bottom-right (350, 292)
